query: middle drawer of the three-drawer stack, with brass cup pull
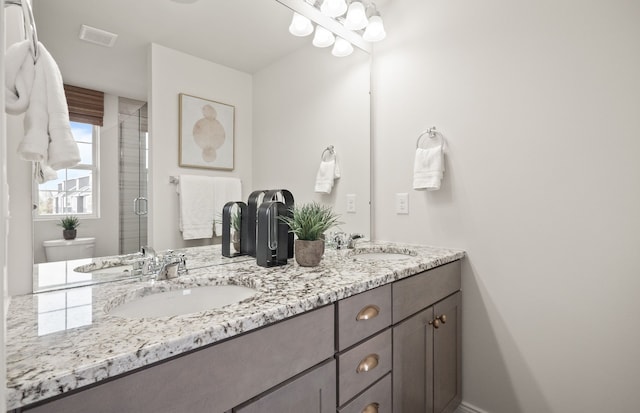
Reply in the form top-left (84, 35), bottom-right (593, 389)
top-left (338, 329), bottom-right (392, 406)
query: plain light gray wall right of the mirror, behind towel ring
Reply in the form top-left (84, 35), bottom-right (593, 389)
top-left (373, 0), bottom-right (640, 413)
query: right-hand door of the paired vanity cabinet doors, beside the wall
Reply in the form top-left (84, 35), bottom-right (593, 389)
top-left (433, 293), bottom-right (462, 413)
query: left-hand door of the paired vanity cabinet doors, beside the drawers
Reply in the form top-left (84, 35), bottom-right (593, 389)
top-left (393, 307), bottom-right (434, 413)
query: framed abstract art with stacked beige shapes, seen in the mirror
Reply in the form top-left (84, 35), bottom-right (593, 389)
top-left (178, 93), bottom-right (236, 171)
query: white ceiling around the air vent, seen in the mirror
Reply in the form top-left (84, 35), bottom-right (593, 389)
top-left (32, 0), bottom-right (310, 100)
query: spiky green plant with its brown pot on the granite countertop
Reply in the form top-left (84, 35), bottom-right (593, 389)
top-left (280, 202), bottom-right (340, 267)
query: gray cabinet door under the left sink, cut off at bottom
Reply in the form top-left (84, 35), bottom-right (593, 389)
top-left (233, 360), bottom-right (336, 413)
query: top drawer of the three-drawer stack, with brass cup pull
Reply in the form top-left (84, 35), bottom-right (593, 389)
top-left (337, 284), bottom-right (391, 351)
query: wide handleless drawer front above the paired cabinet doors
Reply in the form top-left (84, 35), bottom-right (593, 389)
top-left (392, 261), bottom-right (460, 324)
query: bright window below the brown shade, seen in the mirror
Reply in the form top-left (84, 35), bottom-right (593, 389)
top-left (36, 122), bottom-right (100, 218)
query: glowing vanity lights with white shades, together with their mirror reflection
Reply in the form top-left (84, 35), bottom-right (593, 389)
top-left (277, 0), bottom-right (386, 56)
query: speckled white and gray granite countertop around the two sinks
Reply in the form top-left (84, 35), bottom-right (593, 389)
top-left (6, 242), bottom-right (464, 409)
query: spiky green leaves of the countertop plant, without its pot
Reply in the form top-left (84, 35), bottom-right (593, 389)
top-left (280, 202), bottom-right (342, 241)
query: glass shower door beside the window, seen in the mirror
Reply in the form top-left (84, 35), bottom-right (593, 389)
top-left (118, 98), bottom-right (150, 254)
